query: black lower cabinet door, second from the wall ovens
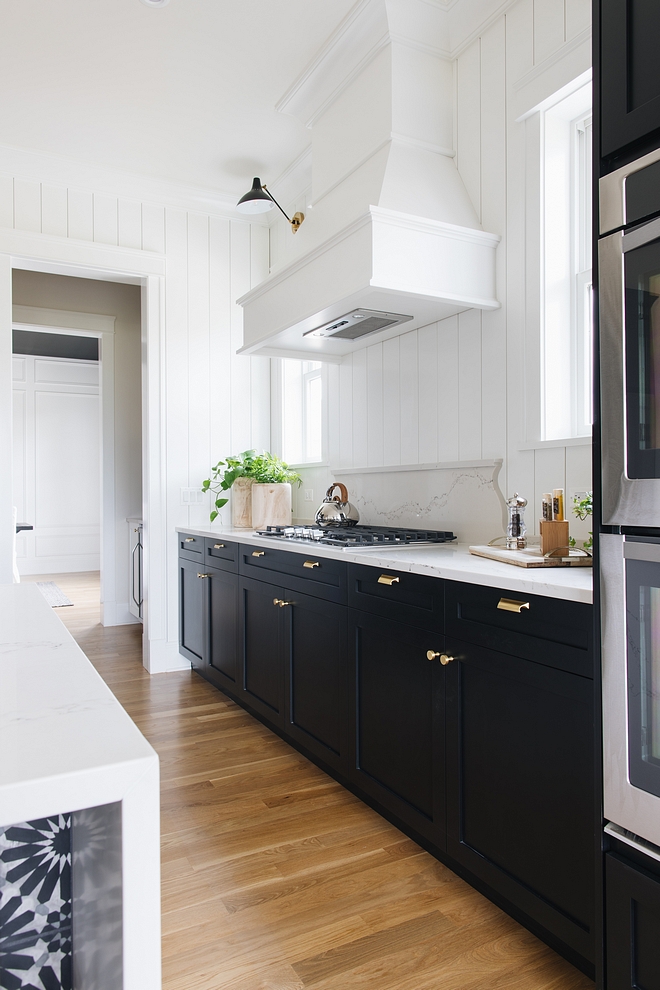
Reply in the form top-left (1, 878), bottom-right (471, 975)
top-left (349, 609), bottom-right (445, 849)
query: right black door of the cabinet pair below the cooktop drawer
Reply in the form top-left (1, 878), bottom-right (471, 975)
top-left (282, 589), bottom-right (348, 774)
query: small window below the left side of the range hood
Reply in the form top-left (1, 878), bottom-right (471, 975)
top-left (274, 358), bottom-right (325, 464)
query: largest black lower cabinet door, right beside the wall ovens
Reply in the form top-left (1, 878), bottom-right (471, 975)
top-left (447, 640), bottom-right (595, 970)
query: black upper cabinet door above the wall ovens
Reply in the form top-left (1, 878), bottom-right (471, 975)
top-left (600, 0), bottom-right (660, 171)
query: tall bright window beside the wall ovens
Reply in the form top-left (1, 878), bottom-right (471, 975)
top-left (541, 85), bottom-right (593, 440)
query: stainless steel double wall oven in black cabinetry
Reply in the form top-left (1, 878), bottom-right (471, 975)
top-left (598, 150), bottom-right (660, 858)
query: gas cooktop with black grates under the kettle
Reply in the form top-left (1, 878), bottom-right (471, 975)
top-left (257, 526), bottom-right (456, 550)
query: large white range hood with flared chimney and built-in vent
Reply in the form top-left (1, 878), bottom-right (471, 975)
top-left (238, 0), bottom-right (500, 361)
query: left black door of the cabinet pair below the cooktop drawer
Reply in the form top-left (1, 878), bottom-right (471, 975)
top-left (239, 578), bottom-right (285, 728)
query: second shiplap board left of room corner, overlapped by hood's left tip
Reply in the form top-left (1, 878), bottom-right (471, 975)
top-left (230, 220), bottom-right (252, 453)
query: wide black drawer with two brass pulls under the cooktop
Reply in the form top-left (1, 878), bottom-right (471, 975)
top-left (239, 544), bottom-right (346, 605)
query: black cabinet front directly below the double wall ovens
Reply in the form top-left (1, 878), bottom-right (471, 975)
top-left (605, 853), bottom-right (660, 990)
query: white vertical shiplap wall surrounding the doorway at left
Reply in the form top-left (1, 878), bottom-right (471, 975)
top-left (0, 174), bottom-right (270, 641)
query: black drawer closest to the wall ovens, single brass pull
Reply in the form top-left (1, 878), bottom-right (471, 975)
top-left (446, 581), bottom-right (593, 677)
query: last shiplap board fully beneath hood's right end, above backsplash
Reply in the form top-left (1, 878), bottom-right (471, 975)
top-left (458, 309), bottom-right (481, 460)
